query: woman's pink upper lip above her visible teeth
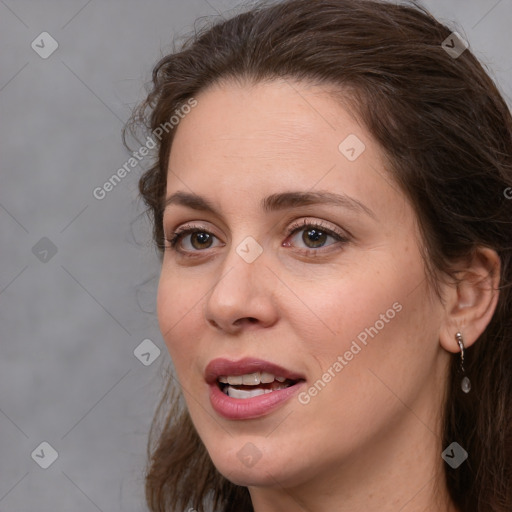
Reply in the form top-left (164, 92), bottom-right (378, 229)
top-left (205, 357), bottom-right (304, 384)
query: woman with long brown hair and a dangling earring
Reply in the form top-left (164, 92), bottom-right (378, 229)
top-left (125, 0), bottom-right (512, 512)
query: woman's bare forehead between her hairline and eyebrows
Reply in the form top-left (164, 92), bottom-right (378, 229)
top-left (167, 80), bottom-right (408, 224)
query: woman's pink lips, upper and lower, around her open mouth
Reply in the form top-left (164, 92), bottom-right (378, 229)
top-left (205, 358), bottom-right (304, 420)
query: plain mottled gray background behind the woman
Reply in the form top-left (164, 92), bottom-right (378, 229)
top-left (0, 0), bottom-right (512, 512)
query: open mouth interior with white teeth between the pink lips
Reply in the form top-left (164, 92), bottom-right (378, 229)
top-left (217, 372), bottom-right (299, 399)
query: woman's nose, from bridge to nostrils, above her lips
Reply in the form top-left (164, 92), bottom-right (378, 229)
top-left (203, 242), bottom-right (278, 334)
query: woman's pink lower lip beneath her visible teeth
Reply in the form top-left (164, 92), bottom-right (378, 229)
top-left (210, 381), bottom-right (304, 420)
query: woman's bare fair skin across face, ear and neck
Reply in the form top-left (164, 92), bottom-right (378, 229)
top-left (157, 77), bottom-right (498, 512)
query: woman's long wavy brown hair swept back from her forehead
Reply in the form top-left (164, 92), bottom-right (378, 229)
top-left (128, 0), bottom-right (512, 512)
